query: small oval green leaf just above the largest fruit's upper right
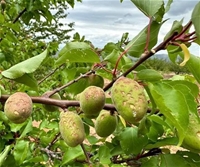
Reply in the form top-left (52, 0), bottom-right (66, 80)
top-left (137, 69), bottom-right (163, 82)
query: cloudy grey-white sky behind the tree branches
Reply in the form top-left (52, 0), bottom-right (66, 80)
top-left (63, 0), bottom-right (200, 56)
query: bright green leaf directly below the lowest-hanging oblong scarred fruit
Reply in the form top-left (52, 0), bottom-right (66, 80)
top-left (62, 145), bottom-right (84, 165)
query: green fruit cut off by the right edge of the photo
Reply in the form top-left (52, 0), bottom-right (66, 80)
top-left (182, 114), bottom-right (200, 153)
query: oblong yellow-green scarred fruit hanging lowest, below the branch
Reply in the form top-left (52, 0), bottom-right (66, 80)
top-left (59, 111), bottom-right (85, 147)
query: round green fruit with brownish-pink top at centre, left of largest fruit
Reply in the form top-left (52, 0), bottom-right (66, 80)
top-left (80, 86), bottom-right (105, 118)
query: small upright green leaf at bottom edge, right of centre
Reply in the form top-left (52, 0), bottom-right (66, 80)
top-left (98, 145), bottom-right (111, 164)
